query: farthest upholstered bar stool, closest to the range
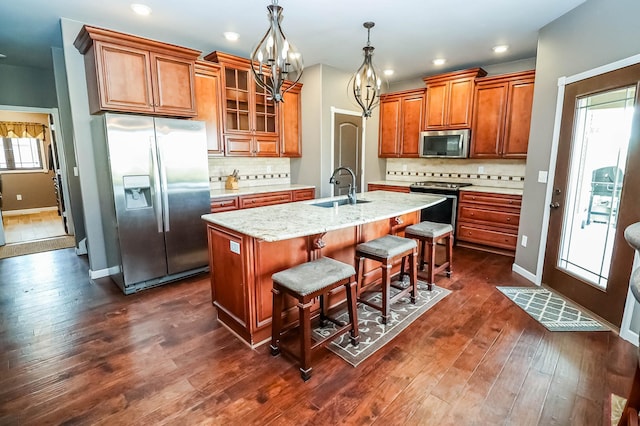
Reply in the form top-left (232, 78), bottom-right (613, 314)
top-left (404, 221), bottom-right (453, 291)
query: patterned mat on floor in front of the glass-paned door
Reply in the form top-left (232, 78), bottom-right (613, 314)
top-left (496, 287), bottom-right (610, 331)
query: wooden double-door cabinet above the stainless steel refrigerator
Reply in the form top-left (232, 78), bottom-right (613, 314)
top-left (74, 25), bottom-right (200, 117)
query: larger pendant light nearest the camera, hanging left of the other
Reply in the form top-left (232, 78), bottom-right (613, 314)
top-left (251, 0), bottom-right (304, 102)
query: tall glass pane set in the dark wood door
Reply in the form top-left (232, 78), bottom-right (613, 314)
top-left (557, 86), bottom-right (636, 289)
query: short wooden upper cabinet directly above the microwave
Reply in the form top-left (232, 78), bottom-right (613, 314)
top-left (423, 68), bottom-right (487, 130)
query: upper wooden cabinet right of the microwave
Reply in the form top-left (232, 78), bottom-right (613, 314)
top-left (469, 71), bottom-right (535, 158)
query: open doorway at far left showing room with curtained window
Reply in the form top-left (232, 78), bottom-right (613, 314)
top-left (0, 106), bottom-right (73, 251)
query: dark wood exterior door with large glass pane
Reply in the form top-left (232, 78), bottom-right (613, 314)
top-left (542, 64), bottom-right (640, 326)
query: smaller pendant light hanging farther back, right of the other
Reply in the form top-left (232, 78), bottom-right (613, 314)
top-left (350, 22), bottom-right (382, 118)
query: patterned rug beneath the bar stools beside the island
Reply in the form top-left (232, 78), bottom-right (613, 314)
top-left (313, 280), bottom-right (451, 367)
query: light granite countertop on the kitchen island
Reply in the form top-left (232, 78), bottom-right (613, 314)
top-left (202, 191), bottom-right (444, 242)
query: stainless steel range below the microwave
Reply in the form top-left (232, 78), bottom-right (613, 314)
top-left (409, 181), bottom-right (471, 236)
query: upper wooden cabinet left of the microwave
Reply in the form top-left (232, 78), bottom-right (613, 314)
top-left (378, 89), bottom-right (424, 157)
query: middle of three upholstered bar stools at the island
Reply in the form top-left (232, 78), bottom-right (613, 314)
top-left (356, 235), bottom-right (418, 324)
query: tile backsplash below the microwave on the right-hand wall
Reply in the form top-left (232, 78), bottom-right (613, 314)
top-left (384, 158), bottom-right (526, 189)
